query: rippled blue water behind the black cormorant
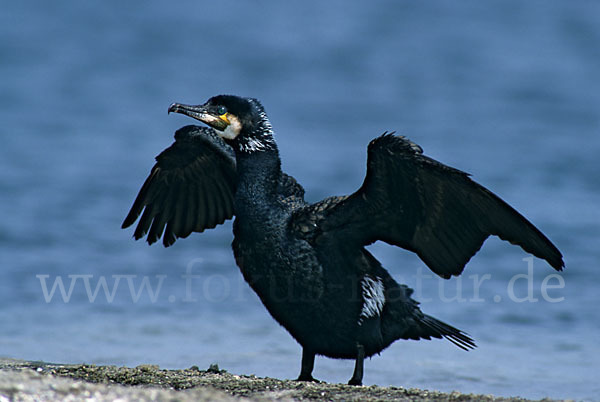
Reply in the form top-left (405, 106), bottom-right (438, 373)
top-left (0, 0), bottom-right (600, 400)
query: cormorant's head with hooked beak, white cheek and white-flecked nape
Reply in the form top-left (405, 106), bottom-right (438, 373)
top-left (169, 95), bottom-right (275, 152)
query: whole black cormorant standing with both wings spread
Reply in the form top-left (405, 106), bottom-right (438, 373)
top-left (123, 95), bottom-right (564, 384)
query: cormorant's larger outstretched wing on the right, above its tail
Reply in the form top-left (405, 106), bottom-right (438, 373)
top-left (293, 133), bottom-right (564, 278)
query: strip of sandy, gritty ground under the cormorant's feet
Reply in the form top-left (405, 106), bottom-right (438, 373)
top-left (0, 359), bottom-right (564, 402)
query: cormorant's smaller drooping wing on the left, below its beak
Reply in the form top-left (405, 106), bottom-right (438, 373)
top-left (122, 126), bottom-right (237, 247)
